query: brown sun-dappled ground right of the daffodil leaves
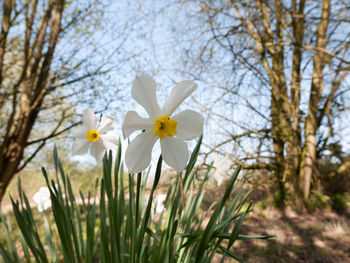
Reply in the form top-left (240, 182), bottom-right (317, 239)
top-left (235, 208), bottom-right (350, 263)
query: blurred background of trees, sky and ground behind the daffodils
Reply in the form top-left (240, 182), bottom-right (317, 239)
top-left (0, 0), bottom-right (350, 262)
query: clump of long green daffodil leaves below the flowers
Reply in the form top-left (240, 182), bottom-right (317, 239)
top-left (0, 139), bottom-right (271, 263)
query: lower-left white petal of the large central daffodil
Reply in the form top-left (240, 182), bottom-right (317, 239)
top-left (125, 131), bottom-right (158, 173)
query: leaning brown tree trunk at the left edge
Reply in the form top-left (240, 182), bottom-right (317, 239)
top-left (0, 0), bottom-right (65, 202)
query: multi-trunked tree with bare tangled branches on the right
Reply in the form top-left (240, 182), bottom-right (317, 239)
top-left (156, 0), bottom-right (350, 208)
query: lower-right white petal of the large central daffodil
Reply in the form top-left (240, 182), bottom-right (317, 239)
top-left (160, 136), bottom-right (188, 172)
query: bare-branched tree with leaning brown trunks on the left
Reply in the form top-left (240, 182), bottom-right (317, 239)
top-left (0, 0), bottom-right (135, 201)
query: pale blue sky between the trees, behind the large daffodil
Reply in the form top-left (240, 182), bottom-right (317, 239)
top-left (31, 0), bottom-right (350, 169)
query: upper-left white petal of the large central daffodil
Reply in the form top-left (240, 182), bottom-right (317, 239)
top-left (131, 76), bottom-right (161, 119)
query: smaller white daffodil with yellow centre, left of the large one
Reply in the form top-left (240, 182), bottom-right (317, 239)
top-left (72, 109), bottom-right (118, 163)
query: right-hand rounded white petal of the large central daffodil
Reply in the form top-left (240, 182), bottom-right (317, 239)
top-left (172, 110), bottom-right (204, 140)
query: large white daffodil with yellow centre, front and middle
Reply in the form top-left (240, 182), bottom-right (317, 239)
top-left (122, 76), bottom-right (204, 173)
